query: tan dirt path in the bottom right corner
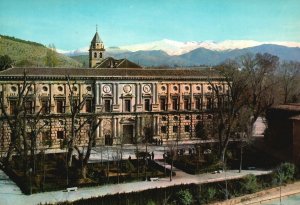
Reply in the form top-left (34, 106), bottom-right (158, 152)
top-left (211, 182), bottom-right (300, 205)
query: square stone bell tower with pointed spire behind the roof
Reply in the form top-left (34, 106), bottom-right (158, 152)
top-left (89, 29), bottom-right (105, 68)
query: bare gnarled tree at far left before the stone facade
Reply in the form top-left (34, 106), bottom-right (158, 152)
top-left (0, 71), bottom-right (43, 176)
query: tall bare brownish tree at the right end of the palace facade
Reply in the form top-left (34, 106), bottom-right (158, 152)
top-left (208, 58), bottom-right (247, 163)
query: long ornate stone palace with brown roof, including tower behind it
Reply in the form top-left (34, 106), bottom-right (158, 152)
top-left (0, 33), bottom-right (228, 148)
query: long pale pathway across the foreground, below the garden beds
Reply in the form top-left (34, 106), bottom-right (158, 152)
top-left (0, 165), bottom-right (269, 205)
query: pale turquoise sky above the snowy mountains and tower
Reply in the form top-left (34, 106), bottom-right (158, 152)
top-left (0, 0), bottom-right (300, 50)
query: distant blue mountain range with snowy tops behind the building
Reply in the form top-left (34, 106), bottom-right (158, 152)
top-left (65, 39), bottom-right (300, 67)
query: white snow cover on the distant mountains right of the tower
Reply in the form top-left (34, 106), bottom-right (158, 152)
top-left (120, 39), bottom-right (300, 56)
